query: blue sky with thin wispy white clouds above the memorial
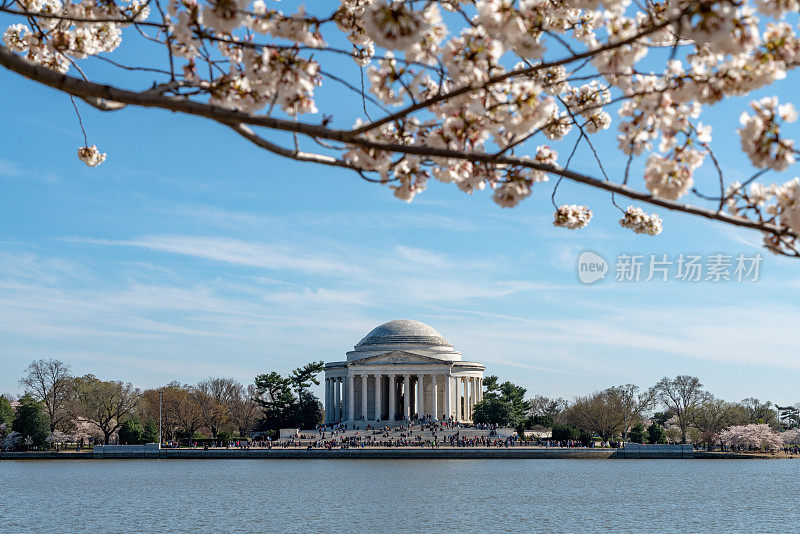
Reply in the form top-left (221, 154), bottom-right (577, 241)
top-left (0, 8), bottom-right (800, 403)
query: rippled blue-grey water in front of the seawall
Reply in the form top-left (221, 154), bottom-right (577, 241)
top-left (0, 460), bottom-right (800, 533)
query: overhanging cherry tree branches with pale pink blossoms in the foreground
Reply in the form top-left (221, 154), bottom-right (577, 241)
top-left (0, 0), bottom-right (800, 256)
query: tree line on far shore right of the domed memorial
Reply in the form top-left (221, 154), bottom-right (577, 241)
top-left (473, 375), bottom-right (800, 448)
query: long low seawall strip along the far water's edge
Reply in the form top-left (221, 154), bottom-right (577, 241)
top-left (0, 447), bottom-right (779, 460)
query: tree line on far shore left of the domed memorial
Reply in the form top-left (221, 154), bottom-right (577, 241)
top-left (0, 359), bottom-right (324, 450)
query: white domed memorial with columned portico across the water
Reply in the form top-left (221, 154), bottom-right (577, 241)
top-left (325, 319), bottom-right (486, 423)
